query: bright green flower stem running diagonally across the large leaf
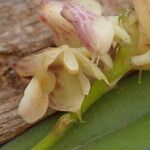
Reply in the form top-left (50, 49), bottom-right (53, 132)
top-left (33, 46), bottom-right (133, 150)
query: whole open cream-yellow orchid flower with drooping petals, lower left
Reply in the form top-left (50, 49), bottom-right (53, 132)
top-left (15, 45), bottom-right (108, 123)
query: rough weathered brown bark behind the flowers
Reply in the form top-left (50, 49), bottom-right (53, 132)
top-left (0, 0), bottom-right (131, 143)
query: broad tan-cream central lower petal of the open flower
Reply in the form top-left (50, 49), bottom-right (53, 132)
top-left (49, 70), bottom-right (85, 112)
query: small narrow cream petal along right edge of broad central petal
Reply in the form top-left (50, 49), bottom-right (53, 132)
top-left (78, 70), bottom-right (91, 95)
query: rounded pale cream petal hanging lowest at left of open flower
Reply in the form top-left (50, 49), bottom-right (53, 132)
top-left (18, 78), bottom-right (48, 123)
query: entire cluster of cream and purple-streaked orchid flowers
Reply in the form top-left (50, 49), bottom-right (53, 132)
top-left (15, 0), bottom-right (150, 123)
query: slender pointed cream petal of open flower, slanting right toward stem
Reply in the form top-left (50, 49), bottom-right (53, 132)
top-left (75, 52), bottom-right (108, 83)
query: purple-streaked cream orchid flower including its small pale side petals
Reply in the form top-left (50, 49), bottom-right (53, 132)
top-left (61, 2), bottom-right (131, 68)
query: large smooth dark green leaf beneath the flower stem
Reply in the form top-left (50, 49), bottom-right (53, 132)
top-left (1, 72), bottom-right (150, 150)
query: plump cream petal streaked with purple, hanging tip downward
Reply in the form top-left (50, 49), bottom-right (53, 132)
top-left (62, 3), bottom-right (115, 54)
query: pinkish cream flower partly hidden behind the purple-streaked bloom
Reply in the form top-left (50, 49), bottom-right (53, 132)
top-left (40, 0), bottom-right (101, 47)
